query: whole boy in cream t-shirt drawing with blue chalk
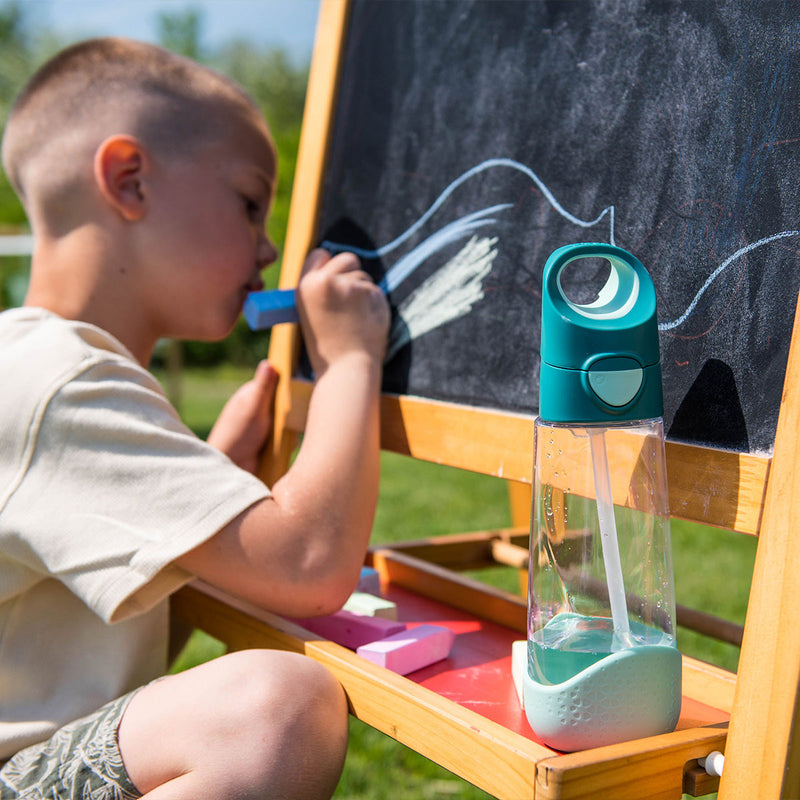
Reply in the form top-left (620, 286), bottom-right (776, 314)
top-left (0, 34), bottom-right (389, 800)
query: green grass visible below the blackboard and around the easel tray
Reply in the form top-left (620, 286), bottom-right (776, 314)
top-left (164, 368), bottom-right (756, 800)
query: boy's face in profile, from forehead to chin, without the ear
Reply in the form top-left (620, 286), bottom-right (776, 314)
top-left (142, 109), bottom-right (277, 340)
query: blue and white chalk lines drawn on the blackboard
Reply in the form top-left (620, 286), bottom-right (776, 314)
top-left (322, 158), bottom-right (800, 348)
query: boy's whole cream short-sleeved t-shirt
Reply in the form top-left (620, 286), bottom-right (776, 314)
top-left (0, 308), bottom-right (269, 760)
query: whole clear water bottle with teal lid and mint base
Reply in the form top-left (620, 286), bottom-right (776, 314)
top-left (523, 244), bottom-right (681, 751)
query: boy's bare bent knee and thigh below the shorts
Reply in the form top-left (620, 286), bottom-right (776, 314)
top-left (119, 650), bottom-right (348, 800)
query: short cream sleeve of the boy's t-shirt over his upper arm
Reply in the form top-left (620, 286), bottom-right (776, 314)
top-left (3, 360), bottom-right (269, 622)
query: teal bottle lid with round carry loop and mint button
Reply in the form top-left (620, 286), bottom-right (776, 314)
top-left (539, 243), bottom-right (664, 424)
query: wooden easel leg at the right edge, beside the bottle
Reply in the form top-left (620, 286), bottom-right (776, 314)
top-left (719, 292), bottom-right (800, 800)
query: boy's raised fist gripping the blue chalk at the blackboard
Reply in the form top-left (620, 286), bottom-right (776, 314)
top-left (297, 250), bottom-right (390, 377)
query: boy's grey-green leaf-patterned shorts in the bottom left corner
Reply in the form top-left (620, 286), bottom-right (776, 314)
top-left (0, 693), bottom-right (141, 800)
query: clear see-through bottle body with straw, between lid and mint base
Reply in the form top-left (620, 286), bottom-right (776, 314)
top-left (528, 418), bottom-right (675, 685)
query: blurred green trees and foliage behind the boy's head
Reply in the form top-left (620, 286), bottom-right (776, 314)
top-left (0, 0), bottom-right (308, 366)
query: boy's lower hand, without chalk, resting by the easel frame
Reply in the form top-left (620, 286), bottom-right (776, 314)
top-left (208, 361), bottom-right (278, 474)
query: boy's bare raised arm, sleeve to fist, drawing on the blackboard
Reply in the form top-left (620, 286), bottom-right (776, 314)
top-left (178, 251), bottom-right (389, 616)
